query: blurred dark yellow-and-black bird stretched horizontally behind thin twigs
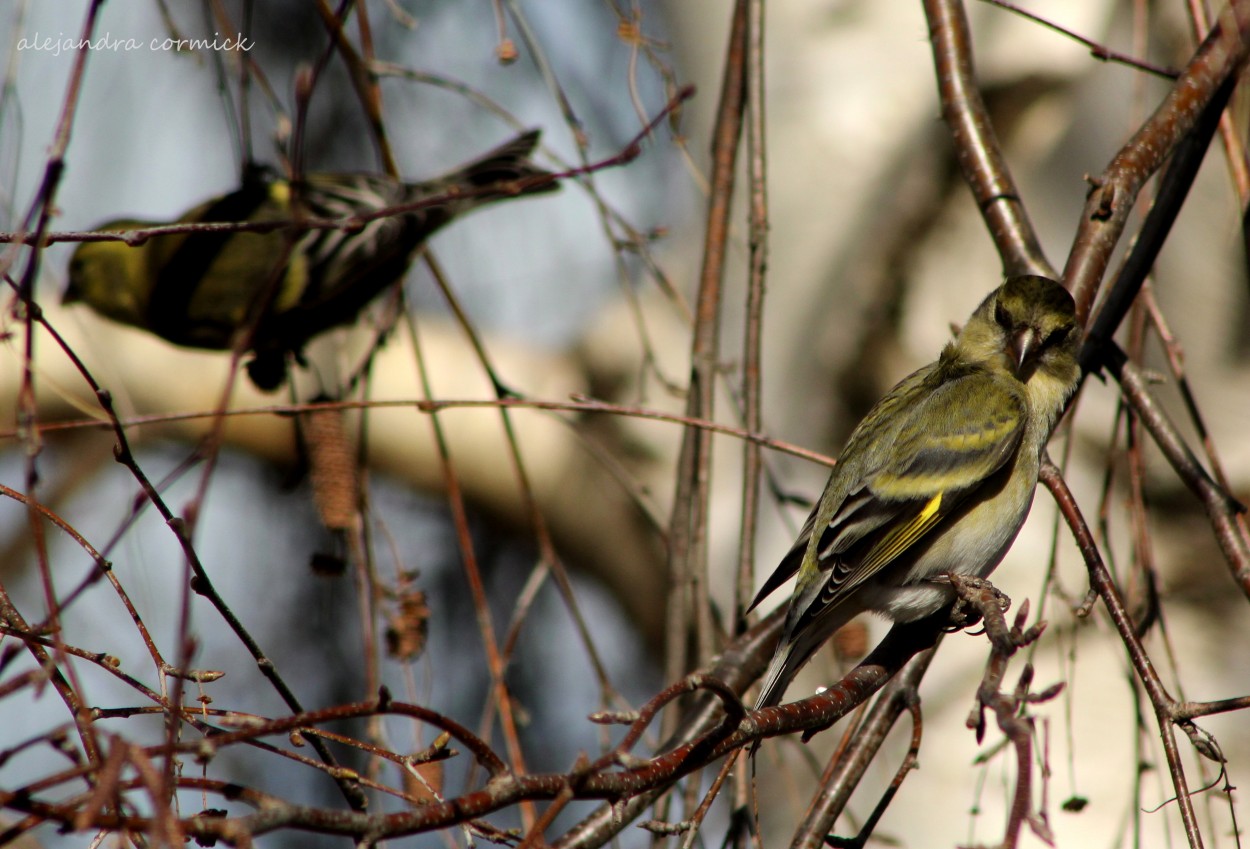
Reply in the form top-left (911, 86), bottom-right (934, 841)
top-left (65, 130), bottom-right (559, 390)
